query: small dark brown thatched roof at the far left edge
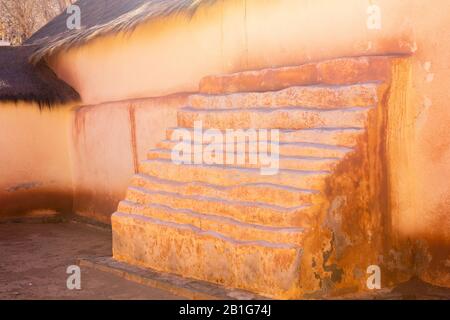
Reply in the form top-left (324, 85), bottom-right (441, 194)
top-left (0, 46), bottom-right (80, 107)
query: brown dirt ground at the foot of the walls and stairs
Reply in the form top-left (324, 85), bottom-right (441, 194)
top-left (0, 221), bottom-right (450, 300)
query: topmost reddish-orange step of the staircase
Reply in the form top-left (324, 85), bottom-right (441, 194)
top-left (200, 56), bottom-right (392, 94)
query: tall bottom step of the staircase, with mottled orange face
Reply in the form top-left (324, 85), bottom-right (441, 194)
top-left (112, 212), bottom-right (302, 299)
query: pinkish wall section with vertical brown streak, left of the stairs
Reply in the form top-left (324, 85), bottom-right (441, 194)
top-left (71, 95), bottom-right (186, 224)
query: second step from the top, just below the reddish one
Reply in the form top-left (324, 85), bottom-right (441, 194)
top-left (188, 83), bottom-right (378, 109)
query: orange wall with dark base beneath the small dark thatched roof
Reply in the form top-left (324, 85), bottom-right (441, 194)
top-left (0, 102), bottom-right (72, 219)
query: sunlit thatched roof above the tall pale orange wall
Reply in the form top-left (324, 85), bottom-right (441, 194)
top-left (26, 0), bottom-right (219, 63)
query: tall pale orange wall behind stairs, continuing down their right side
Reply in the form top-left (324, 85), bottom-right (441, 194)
top-left (46, 0), bottom-right (450, 285)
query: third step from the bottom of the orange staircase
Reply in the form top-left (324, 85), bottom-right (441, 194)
top-left (126, 187), bottom-right (313, 227)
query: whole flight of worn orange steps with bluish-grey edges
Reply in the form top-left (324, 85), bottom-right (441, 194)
top-left (112, 58), bottom-right (394, 298)
